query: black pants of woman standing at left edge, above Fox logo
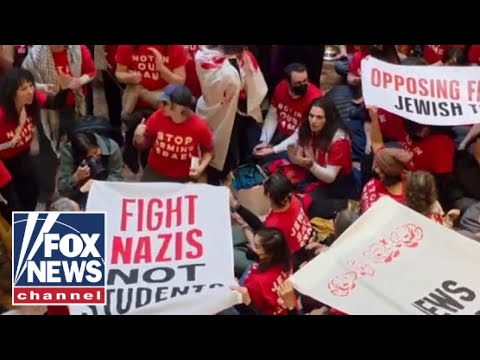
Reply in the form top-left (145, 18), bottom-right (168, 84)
top-left (1, 151), bottom-right (38, 217)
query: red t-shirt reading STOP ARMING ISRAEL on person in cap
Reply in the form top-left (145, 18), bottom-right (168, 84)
top-left (145, 109), bottom-right (213, 179)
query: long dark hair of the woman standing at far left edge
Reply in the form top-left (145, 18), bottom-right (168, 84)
top-left (0, 68), bottom-right (39, 124)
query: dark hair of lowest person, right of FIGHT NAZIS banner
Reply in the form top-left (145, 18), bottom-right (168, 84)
top-left (255, 228), bottom-right (291, 271)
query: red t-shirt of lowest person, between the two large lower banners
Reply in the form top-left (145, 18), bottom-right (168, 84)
top-left (244, 264), bottom-right (291, 315)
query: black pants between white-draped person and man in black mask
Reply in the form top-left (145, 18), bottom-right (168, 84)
top-left (207, 114), bottom-right (261, 185)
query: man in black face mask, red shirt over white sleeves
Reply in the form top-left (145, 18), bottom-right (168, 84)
top-left (253, 63), bottom-right (322, 163)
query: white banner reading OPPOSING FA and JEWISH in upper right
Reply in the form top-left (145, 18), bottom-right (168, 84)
top-left (361, 57), bottom-right (480, 126)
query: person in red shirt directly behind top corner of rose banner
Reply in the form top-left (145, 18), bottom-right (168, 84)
top-left (360, 148), bottom-right (412, 213)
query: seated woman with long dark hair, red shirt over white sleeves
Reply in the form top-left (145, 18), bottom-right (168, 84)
top-left (282, 98), bottom-right (360, 219)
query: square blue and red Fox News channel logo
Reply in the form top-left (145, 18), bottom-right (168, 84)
top-left (12, 212), bottom-right (106, 305)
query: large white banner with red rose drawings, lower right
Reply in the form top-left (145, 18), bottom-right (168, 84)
top-left (291, 196), bottom-right (480, 315)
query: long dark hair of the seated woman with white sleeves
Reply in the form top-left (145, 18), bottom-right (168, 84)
top-left (298, 98), bottom-right (350, 151)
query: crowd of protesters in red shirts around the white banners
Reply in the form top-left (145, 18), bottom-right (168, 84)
top-left (0, 45), bottom-right (480, 315)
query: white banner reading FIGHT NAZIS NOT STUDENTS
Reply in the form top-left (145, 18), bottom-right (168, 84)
top-left (70, 182), bottom-right (241, 315)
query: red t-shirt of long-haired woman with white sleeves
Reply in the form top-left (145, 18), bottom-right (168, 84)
top-left (316, 130), bottom-right (353, 176)
